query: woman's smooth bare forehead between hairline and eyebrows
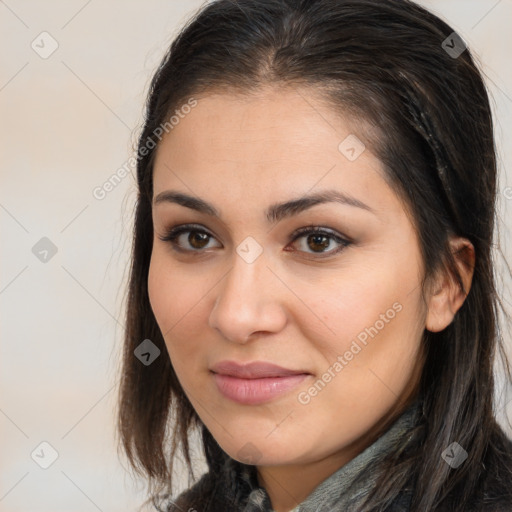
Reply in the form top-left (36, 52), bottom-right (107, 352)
top-left (153, 88), bottom-right (404, 222)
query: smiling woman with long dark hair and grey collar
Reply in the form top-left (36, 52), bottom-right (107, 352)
top-left (119, 0), bottom-right (512, 512)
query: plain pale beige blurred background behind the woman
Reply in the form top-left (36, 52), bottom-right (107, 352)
top-left (0, 0), bottom-right (512, 512)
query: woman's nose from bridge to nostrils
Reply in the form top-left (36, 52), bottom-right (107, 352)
top-left (209, 245), bottom-right (286, 343)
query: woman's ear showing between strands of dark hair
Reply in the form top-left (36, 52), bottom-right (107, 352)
top-left (425, 237), bottom-right (475, 332)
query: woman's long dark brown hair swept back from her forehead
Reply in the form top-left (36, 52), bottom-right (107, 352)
top-left (118, 0), bottom-right (512, 511)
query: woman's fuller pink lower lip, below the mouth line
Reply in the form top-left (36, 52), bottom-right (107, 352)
top-left (213, 373), bottom-right (309, 405)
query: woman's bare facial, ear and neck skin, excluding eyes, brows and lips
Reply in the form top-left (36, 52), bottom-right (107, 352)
top-left (148, 88), bottom-right (473, 512)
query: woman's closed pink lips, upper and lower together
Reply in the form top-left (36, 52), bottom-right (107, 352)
top-left (210, 361), bottom-right (311, 405)
